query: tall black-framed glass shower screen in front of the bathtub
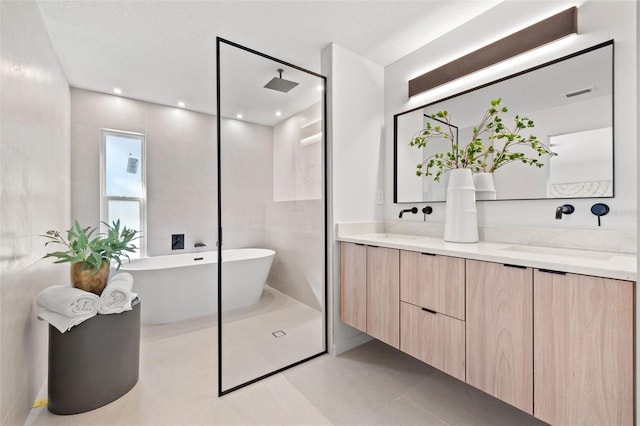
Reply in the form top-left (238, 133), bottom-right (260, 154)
top-left (217, 38), bottom-right (326, 395)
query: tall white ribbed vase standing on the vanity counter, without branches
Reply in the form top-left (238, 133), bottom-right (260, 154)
top-left (444, 169), bottom-right (478, 243)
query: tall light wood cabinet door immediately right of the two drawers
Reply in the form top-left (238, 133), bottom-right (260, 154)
top-left (466, 260), bottom-right (533, 414)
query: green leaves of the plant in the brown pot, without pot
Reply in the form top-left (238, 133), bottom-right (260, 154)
top-left (41, 219), bottom-right (139, 273)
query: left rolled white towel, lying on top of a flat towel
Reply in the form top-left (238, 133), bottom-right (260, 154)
top-left (36, 285), bottom-right (100, 317)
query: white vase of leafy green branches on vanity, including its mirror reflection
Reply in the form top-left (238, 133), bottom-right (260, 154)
top-left (409, 98), bottom-right (556, 243)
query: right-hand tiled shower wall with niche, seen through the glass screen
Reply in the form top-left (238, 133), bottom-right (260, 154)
top-left (265, 103), bottom-right (324, 310)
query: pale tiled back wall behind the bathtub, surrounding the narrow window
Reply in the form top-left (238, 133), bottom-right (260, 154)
top-left (71, 88), bottom-right (272, 256)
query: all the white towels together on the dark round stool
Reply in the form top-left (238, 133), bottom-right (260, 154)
top-left (36, 272), bottom-right (138, 333)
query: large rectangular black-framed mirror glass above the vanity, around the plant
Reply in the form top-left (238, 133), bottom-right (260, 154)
top-left (394, 40), bottom-right (614, 203)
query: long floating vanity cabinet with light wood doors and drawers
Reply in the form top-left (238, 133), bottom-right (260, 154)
top-left (340, 243), bottom-right (635, 425)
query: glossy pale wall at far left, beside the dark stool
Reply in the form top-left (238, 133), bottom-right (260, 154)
top-left (0, 1), bottom-right (70, 425)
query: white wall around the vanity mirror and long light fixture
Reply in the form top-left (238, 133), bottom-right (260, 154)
top-left (385, 0), bottom-right (638, 233)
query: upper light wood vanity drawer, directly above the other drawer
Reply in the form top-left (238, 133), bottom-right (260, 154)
top-left (400, 250), bottom-right (465, 320)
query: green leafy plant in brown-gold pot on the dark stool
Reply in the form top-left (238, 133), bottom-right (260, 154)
top-left (42, 219), bottom-right (139, 295)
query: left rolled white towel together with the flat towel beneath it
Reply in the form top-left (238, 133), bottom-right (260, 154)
top-left (36, 285), bottom-right (100, 333)
